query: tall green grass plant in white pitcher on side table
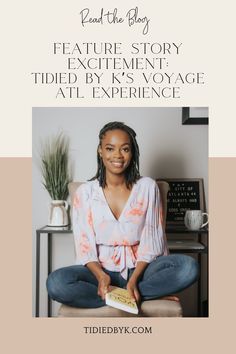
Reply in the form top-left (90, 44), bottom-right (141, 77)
top-left (41, 133), bottom-right (72, 226)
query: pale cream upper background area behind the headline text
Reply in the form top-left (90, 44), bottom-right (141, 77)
top-left (0, 0), bottom-right (236, 157)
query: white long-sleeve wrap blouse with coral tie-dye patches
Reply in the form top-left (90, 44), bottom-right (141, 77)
top-left (73, 177), bottom-right (168, 279)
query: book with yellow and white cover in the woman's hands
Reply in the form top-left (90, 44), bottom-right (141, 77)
top-left (105, 287), bottom-right (138, 314)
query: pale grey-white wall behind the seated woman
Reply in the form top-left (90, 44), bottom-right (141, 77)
top-left (32, 107), bottom-right (208, 316)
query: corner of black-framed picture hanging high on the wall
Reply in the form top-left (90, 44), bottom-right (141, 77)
top-left (182, 107), bottom-right (208, 125)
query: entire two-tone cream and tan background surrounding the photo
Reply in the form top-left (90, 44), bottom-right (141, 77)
top-left (0, 0), bottom-right (236, 353)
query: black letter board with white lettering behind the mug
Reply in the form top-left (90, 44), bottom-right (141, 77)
top-left (158, 178), bottom-right (206, 226)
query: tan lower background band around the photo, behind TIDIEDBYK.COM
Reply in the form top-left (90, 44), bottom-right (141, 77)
top-left (0, 158), bottom-right (236, 354)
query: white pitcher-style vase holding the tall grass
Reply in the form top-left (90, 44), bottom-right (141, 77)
top-left (48, 200), bottom-right (69, 227)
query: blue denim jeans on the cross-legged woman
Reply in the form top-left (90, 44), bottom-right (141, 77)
top-left (47, 254), bottom-right (198, 308)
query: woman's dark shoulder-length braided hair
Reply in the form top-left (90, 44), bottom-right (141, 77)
top-left (90, 122), bottom-right (140, 188)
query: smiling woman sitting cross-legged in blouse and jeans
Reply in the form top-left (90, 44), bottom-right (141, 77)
top-left (47, 122), bottom-right (198, 308)
